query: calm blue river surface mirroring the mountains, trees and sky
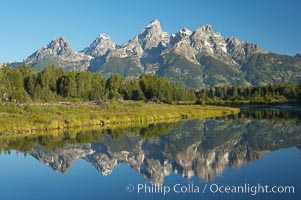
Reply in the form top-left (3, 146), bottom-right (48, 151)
top-left (0, 106), bottom-right (301, 200)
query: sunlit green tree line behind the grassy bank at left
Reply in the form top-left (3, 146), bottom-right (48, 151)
top-left (0, 63), bottom-right (196, 103)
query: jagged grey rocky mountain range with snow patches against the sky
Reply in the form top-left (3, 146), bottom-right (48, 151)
top-left (26, 20), bottom-right (301, 88)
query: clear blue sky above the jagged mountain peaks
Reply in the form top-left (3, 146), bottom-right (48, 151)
top-left (0, 0), bottom-right (301, 62)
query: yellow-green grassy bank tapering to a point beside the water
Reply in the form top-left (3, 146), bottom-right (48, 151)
top-left (0, 101), bottom-right (239, 135)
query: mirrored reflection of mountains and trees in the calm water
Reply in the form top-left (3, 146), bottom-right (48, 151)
top-left (0, 110), bottom-right (301, 182)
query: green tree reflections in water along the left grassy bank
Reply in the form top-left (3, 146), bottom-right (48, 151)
top-left (0, 123), bottom-right (179, 152)
